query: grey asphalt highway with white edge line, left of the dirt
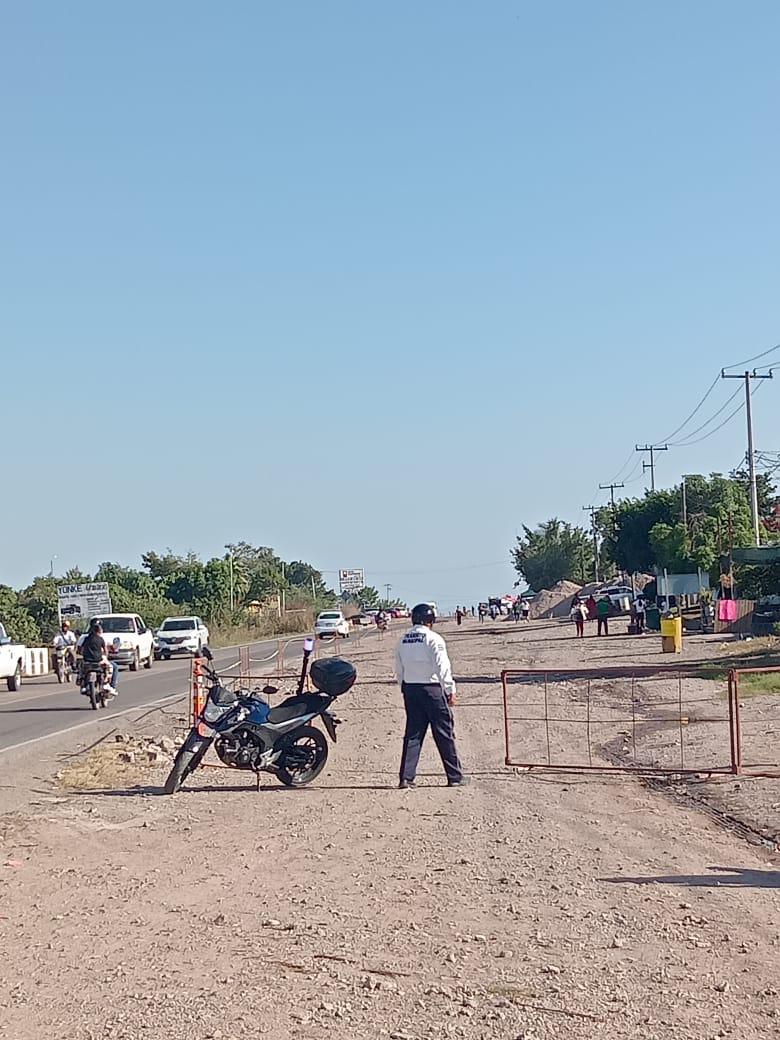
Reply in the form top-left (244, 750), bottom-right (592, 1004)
top-left (0, 636), bottom-right (314, 755)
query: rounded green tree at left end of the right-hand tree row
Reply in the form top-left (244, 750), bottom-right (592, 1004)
top-left (512, 517), bottom-right (594, 591)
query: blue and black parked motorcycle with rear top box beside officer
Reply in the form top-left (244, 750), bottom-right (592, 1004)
top-left (165, 640), bottom-right (357, 795)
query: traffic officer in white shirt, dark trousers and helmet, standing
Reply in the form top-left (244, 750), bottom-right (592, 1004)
top-left (395, 603), bottom-right (466, 789)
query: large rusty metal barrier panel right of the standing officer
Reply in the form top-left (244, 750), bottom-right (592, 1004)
top-left (501, 666), bottom-right (739, 776)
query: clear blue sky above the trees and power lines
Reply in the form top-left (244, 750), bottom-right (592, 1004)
top-left (0, 0), bottom-right (780, 605)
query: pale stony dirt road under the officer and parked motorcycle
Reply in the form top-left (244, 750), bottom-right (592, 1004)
top-left (0, 622), bottom-right (780, 1040)
